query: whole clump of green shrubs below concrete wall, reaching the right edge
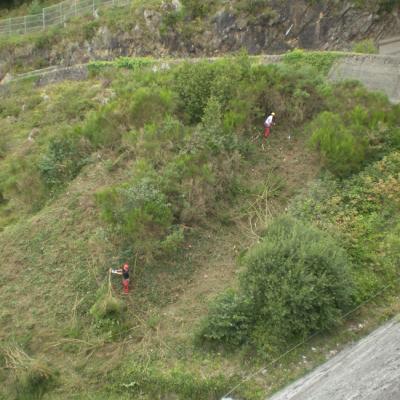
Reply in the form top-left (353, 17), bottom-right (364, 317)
top-left (307, 95), bottom-right (400, 177)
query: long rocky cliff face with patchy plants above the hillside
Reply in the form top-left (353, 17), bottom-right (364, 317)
top-left (0, 0), bottom-right (400, 79)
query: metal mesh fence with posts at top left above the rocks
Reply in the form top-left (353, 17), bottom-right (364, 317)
top-left (0, 0), bottom-right (130, 36)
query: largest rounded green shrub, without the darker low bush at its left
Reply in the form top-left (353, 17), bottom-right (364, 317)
top-left (240, 217), bottom-right (353, 342)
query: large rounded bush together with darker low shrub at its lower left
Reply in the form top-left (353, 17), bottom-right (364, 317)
top-left (200, 217), bottom-right (353, 352)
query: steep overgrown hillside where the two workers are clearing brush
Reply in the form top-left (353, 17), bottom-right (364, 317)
top-left (0, 52), bottom-right (400, 399)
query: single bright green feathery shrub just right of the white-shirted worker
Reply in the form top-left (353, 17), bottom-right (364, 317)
top-left (310, 111), bottom-right (367, 176)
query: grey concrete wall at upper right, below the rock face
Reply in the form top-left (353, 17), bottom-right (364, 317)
top-left (329, 55), bottom-right (400, 103)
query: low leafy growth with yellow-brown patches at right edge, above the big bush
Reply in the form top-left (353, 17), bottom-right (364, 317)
top-left (290, 151), bottom-right (400, 302)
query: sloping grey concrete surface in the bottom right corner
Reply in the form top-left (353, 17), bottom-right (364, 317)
top-left (270, 322), bottom-right (400, 400)
